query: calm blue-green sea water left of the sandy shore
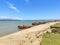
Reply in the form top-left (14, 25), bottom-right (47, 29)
top-left (0, 20), bottom-right (46, 36)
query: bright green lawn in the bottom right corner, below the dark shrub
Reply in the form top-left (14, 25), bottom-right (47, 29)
top-left (41, 33), bottom-right (60, 45)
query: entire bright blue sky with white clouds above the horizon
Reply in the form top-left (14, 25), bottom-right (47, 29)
top-left (0, 0), bottom-right (60, 20)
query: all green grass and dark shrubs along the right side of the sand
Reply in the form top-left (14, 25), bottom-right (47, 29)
top-left (41, 23), bottom-right (60, 45)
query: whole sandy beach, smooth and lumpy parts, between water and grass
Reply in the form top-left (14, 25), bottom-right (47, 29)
top-left (0, 22), bottom-right (58, 45)
